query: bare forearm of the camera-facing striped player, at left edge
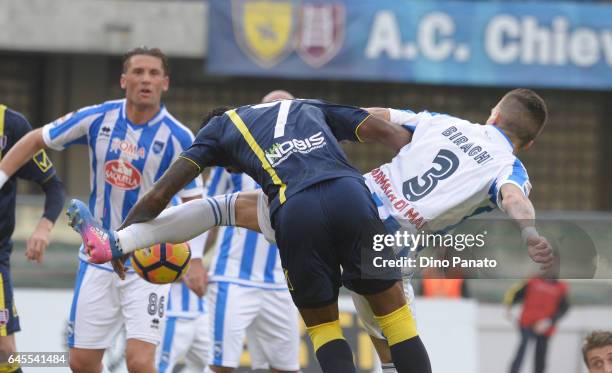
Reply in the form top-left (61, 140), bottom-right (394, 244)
top-left (0, 128), bottom-right (47, 188)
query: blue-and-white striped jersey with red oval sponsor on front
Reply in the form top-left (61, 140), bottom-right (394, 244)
top-left (43, 99), bottom-right (202, 268)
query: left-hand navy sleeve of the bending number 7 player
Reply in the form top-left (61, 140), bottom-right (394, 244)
top-left (179, 115), bottom-right (232, 172)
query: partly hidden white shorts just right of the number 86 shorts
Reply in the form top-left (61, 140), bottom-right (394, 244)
top-left (155, 313), bottom-right (210, 373)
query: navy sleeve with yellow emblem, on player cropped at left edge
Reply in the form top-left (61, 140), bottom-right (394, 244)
top-left (6, 111), bottom-right (55, 184)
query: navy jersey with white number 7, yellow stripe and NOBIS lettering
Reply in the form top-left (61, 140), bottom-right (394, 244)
top-left (181, 100), bottom-right (368, 214)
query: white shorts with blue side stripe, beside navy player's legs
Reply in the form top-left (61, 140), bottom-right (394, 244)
top-left (206, 282), bottom-right (300, 371)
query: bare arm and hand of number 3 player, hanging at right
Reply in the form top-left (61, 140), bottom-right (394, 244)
top-left (500, 184), bottom-right (554, 270)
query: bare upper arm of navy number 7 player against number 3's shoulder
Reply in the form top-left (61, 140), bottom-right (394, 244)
top-left (357, 108), bottom-right (412, 152)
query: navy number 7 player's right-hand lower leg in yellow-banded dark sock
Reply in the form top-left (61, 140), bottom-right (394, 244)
top-left (365, 281), bottom-right (431, 373)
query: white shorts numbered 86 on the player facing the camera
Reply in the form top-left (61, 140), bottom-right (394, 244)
top-left (68, 261), bottom-right (170, 349)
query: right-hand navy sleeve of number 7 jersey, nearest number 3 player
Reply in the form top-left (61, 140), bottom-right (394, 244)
top-left (307, 100), bottom-right (370, 142)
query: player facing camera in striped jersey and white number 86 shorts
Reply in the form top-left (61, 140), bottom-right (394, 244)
top-left (0, 48), bottom-right (207, 372)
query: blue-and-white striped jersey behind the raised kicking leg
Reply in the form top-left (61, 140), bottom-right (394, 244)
top-left (206, 167), bottom-right (287, 289)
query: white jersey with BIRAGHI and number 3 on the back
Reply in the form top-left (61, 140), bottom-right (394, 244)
top-left (365, 110), bottom-right (531, 231)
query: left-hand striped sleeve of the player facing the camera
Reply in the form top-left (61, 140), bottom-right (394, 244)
top-left (43, 106), bottom-right (103, 150)
